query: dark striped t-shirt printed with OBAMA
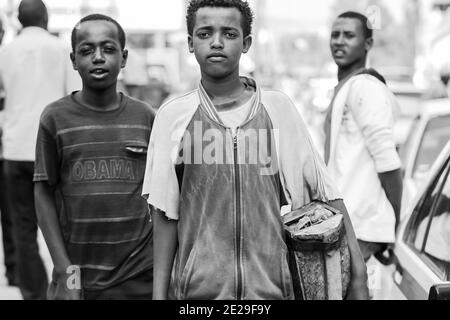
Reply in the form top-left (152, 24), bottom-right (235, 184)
top-left (34, 94), bottom-right (154, 290)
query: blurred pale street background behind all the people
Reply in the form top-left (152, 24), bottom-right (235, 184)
top-left (0, 0), bottom-right (450, 299)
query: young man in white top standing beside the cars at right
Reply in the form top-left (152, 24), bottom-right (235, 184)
top-left (325, 12), bottom-right (402, 261)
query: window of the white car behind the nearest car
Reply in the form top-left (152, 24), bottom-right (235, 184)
top-left (413, 115), bottom-right (450, 177)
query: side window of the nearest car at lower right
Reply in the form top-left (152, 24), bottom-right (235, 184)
top-left (405, 156), bottom-right (450, 280)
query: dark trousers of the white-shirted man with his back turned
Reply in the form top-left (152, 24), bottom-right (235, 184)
top-left (4, 160), bottom-right (48, 300)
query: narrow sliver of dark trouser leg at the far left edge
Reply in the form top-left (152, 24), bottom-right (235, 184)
top-left (0, 160), bottom-right (17, 284)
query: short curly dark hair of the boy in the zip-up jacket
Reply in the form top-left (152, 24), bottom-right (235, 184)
top-left (186, 0), bottom-right (254, 37)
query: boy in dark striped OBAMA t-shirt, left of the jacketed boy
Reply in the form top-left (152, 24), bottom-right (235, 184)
top-left (34, 14), bottom-right (154, 299)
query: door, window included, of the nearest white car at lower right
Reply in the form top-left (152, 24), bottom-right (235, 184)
top-left (394, 158), bottom-right (450, 300)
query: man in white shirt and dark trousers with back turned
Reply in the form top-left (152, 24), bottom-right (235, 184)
top-left (0, 0), bottom-right (80, 299)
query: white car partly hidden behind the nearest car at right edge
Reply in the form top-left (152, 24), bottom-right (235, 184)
top-left (400, 99), bottom-right (450, 216)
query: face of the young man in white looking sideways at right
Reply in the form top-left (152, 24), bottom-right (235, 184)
top-left (330, 18), bottom-right (372, 68)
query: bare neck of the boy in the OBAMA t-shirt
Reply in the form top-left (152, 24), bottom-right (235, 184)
top-left (79, 86), bottom-right (120, 111)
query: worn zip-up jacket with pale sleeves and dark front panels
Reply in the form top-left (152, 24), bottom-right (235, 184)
top-left (143, 79), bottom-right (340, 300)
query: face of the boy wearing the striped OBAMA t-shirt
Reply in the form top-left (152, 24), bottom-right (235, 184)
top-left (70, 20), bottom-right (128, 89)
